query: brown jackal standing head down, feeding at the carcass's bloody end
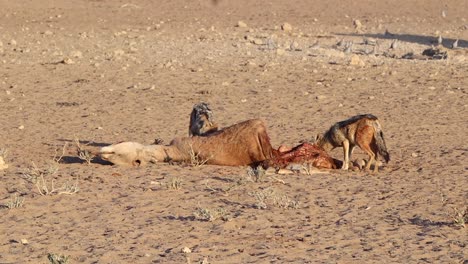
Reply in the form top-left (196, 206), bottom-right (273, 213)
top-left (316, 114), bottom-right (390, 172)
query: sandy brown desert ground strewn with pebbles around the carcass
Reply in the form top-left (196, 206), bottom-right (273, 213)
top-left (0, 0), bottom-right (468, 264)
